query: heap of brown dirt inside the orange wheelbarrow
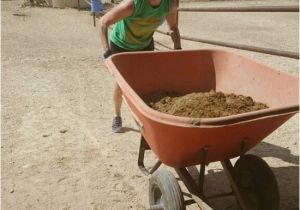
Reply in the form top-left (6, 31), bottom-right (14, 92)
top-left (144, 90), bottom-right (268, 118)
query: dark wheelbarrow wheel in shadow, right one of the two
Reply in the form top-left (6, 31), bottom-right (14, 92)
top-left (234, 155), bottom-right (279, 210)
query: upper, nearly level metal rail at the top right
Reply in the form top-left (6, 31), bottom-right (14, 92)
top-left (177, 5), bottom-right (299, 12)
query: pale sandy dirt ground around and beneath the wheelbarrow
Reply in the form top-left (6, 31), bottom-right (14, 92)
top-left (1, 0), bottom-right (299, 210)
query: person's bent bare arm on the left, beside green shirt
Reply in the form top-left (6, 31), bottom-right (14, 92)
top-left (98, 0), bottom-right (134, 57)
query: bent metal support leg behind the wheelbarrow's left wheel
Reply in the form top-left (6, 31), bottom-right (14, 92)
top-left (138, 135), bottom-right (161, 176)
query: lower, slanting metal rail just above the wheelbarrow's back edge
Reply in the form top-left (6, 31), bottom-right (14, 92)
top-left (156, 30), bottom-right (299, 59)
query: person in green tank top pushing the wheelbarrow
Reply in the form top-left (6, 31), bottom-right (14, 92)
top-left (98, 0), bottom-right (181, 133)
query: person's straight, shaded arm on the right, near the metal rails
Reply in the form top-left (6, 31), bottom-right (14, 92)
top-left (166, 0), bottom-right (181, 49)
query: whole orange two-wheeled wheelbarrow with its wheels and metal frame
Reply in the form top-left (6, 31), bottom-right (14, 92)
top-left (106, 49), bottom-right (299, 210)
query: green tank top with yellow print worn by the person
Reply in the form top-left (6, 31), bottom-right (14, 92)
top-left (110, 0), bottom-right (171, 51)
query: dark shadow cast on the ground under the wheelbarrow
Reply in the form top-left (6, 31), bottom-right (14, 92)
top-left (182, 142), bottom-right (299, 210)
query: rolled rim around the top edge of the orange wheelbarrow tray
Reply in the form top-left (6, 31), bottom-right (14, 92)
top-left (105, 49), bottom-right (299, 127)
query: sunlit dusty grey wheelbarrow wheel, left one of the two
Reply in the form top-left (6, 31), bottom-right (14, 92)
top-left (149, 169), bottom-right (185, 210)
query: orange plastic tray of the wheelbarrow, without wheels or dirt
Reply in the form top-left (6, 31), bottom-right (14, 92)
top-left (106, 49), bottom-right (299, 168)
